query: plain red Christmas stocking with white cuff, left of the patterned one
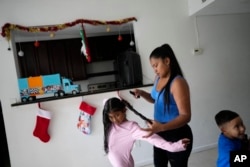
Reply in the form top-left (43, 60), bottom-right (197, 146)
top-left (33, 108), bottom-right (51, 143)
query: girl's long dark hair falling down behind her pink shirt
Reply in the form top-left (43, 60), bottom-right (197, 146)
top-left (102, 97), bottom-right (126, 153)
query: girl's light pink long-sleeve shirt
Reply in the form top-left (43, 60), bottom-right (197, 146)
top-left (108, 121), bottom-right (185, 167)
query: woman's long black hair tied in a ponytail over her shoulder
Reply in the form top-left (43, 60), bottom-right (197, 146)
top-left (149, 44), bottom-right (183, 106)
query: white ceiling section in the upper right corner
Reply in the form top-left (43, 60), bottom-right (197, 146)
top-left (196, 0), bottom-right (250, 15)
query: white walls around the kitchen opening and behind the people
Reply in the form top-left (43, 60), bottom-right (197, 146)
top-left (0, 0), bottom-right (250, 167)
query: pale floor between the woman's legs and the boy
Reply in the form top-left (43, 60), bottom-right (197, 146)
top-left (143, 148), bottom-right (217, 167)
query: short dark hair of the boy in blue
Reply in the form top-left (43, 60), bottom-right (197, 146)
top-left (214, 110), bottom-right (239, 126)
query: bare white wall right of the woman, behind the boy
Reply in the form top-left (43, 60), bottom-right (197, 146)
top-left (187, 14), bottom-right (250, 148)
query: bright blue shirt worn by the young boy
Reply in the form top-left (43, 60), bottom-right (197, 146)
top-left (217, 133), bottom-right (241, 167)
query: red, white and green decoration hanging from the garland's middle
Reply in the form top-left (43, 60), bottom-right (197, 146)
top-left (80, 24), bottom-right (91, 63)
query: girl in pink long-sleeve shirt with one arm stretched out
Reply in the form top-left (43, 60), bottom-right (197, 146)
top-left (103, 97), bottom-right (190, 167)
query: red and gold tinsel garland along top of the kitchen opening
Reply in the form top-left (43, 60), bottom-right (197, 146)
top-left (1, 17), bottom-right (137, 41)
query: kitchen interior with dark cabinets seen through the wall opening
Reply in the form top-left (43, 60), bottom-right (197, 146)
top-left (12, 22), bottom-right (140, 92)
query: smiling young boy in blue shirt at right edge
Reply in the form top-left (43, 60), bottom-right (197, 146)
top-left (215, 110), bottom-right (249, 167)
